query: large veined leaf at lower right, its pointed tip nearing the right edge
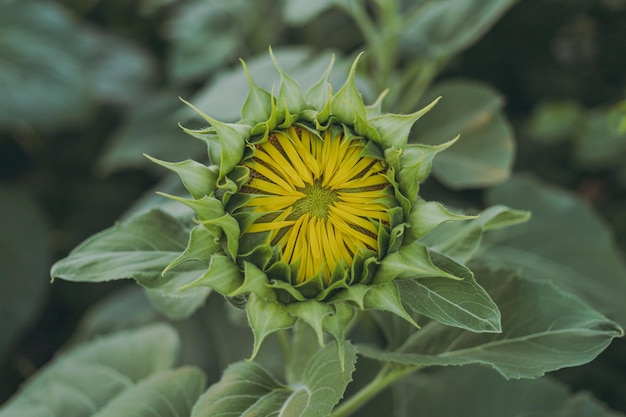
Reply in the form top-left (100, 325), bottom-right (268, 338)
top-left (359, 270), bottom-right (623, 378)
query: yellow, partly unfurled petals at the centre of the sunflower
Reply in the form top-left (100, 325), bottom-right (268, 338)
top-left (240, 126), bottom-right (395, 284)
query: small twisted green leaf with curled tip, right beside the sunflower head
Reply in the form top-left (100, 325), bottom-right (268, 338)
top-left (421, 205), bottom-right (530, 263)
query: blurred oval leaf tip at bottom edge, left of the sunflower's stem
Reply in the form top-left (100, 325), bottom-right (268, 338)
top-left (94, 367), bottom-right (206, 417)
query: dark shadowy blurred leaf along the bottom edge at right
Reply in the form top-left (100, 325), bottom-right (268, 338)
top-left (394, 366), bottom-right (623, 417)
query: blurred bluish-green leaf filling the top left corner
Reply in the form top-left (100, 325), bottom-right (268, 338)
top-left (0, 0), bottom-right (154, 128)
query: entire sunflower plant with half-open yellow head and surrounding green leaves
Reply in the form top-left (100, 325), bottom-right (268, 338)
top-left (0, 0), bottom-right (626, 417)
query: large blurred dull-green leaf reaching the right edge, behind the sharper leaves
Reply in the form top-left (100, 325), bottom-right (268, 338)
top-left (479, 176), bottom-right (626, 326)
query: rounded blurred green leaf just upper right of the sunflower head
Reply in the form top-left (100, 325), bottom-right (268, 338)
top-left (414, 81), bottom-right (515, 189)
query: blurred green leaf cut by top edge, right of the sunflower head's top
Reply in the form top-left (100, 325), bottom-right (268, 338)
top-left (402, 0), bottom-right (514, 58)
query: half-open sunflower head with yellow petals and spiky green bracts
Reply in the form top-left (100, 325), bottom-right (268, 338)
top-left (151, 51), bottom-right (452, 353)
